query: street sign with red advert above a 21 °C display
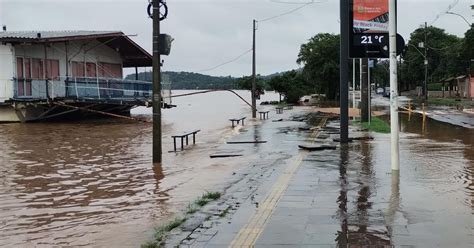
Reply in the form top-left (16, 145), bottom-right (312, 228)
top-left (349, 0), bottom-right (405, 58)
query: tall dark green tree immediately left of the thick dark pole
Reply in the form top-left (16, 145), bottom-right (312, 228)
top-left (296, 33), bottom-right (340, 100)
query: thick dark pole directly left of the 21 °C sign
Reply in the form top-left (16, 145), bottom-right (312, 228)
top-left (339, 0), bottom-right (352, 143)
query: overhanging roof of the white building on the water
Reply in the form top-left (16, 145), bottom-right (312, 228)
top-left (0, 31), bottom-right (152, 67)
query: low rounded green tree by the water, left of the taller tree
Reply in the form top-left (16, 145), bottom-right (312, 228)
top-left (268, 70), bottom-right (314, 103)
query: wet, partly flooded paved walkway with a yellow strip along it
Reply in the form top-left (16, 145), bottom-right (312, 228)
top-left (167, 108), bottom-right (474, 247)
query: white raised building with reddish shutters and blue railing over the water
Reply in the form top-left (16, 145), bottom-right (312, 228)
top-left (0, 31), bottom-right (152, 122)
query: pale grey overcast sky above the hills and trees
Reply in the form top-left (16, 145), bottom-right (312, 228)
top-left (0, 0), bottom-right (474, 76)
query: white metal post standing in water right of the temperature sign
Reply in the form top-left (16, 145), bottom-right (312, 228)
top-left (388, 0), bottom-right (400, 171)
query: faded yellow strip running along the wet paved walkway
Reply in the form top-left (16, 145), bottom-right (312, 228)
top-left (229, 118), bottom-right (327, 247)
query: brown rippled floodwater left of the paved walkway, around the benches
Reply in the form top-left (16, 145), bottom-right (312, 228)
top-left (0, 91), bottom-right (278, 247)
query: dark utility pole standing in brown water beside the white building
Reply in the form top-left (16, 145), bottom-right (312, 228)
top-left (152, 0), bottom-right (162, 164)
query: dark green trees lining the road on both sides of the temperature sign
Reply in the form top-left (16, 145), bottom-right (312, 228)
top-left (254, 25), bottom-right (474, 102)
